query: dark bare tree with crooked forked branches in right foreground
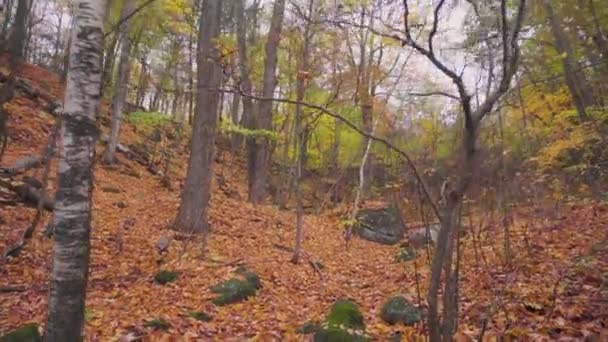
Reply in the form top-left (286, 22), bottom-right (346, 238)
top-left (385, 0), bottom-right (526, 342)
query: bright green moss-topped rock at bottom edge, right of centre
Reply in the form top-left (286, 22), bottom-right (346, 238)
top-left (313, 299), bottom-right (367, 342)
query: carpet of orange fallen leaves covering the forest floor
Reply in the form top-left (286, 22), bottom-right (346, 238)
top-left (0, 62), bottom-right (608, 341)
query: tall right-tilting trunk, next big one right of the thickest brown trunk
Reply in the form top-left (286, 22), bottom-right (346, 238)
top-left (248, 0), bottom-right (285, 204)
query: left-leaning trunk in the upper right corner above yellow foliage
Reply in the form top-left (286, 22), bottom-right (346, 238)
top-left (543, 0), bottom-right (594, 121)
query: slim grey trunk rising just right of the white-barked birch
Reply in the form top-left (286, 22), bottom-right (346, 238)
top-left (103, 0), bottom-right (135, 164)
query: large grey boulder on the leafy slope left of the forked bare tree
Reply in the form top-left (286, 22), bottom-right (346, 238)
top-left (353, 207), bottom-right (405, 245)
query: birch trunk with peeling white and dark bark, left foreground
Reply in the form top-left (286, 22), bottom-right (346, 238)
top-left (45, 0), bottom-right (106, 342)
